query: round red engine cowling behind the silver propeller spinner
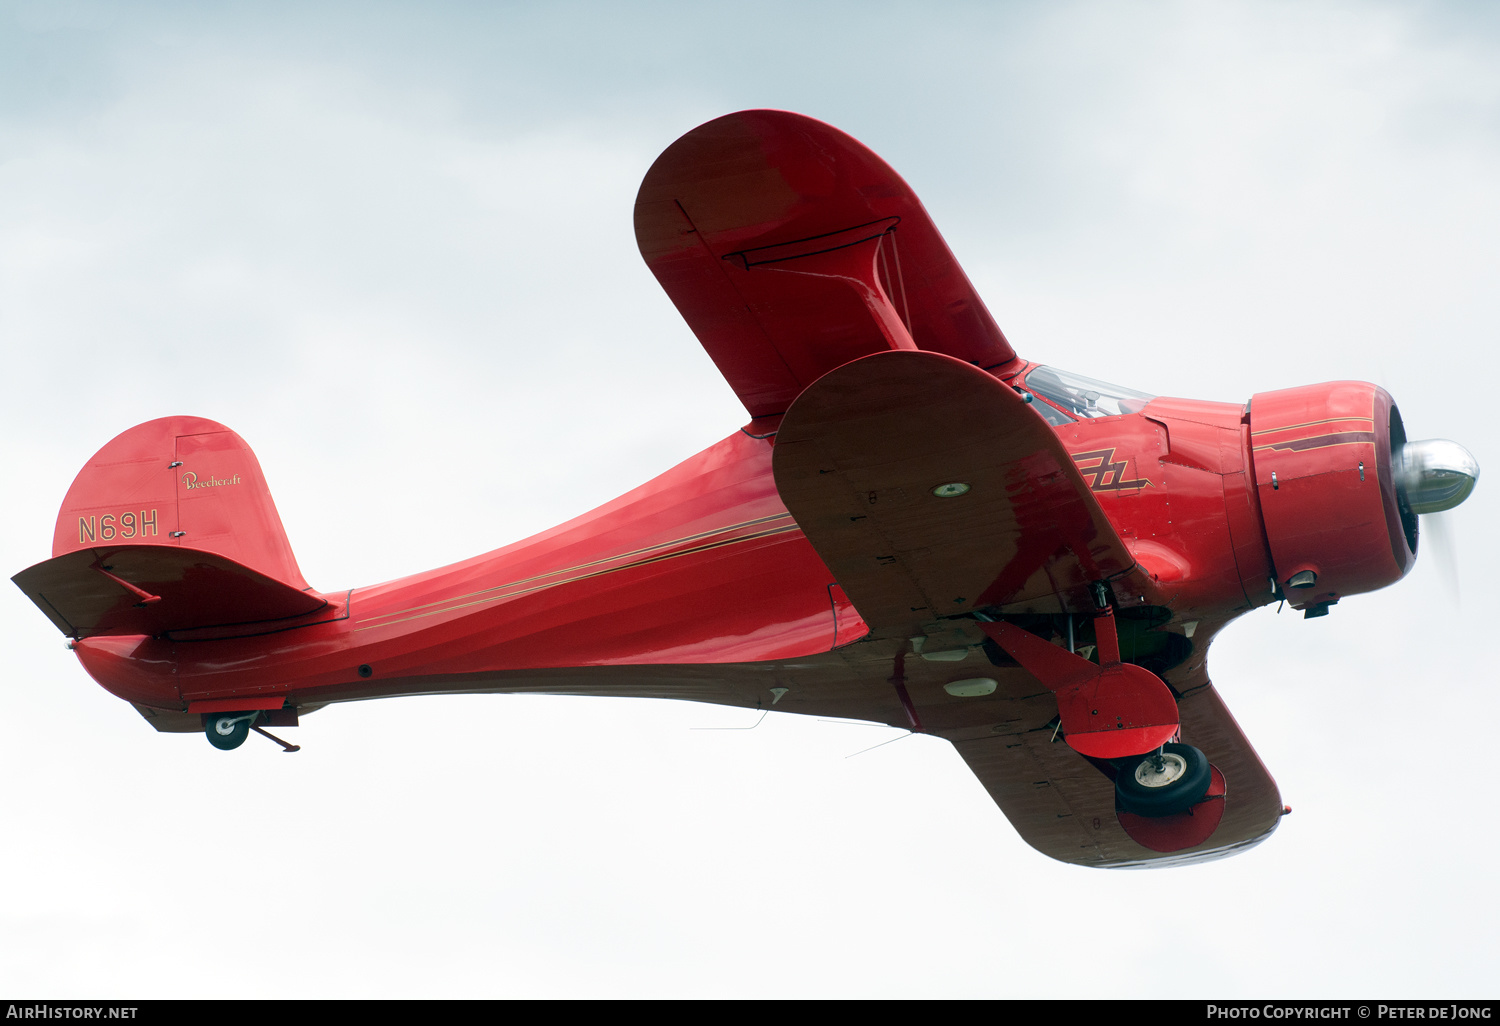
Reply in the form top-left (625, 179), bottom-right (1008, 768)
top-left (1250, 381), bottom-right (1418, 615)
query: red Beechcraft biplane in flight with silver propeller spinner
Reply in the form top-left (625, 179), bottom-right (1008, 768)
top-left (15, 111), bottom-right (1479, 866)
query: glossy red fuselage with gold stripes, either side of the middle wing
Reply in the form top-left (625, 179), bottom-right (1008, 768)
top-left (77, 364), bottom-right (1314, 726)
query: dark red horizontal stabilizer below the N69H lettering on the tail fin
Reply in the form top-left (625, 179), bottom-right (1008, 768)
top-left (12, 545), bottom-right (327, 638)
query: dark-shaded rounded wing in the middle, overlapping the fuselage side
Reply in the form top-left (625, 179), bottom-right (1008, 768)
top-left (773, 353), bottom-right (1134, 638)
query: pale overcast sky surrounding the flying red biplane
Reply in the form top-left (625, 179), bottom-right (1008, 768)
top-left (0, 0), bottom-right (1500, 998)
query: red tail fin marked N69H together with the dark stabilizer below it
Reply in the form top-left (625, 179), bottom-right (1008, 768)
top-left (15, 417), bottom-right (326, 638)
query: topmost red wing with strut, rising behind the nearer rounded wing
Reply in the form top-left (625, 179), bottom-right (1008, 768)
top-left (636, 111), bottom-right (1016, 417)
